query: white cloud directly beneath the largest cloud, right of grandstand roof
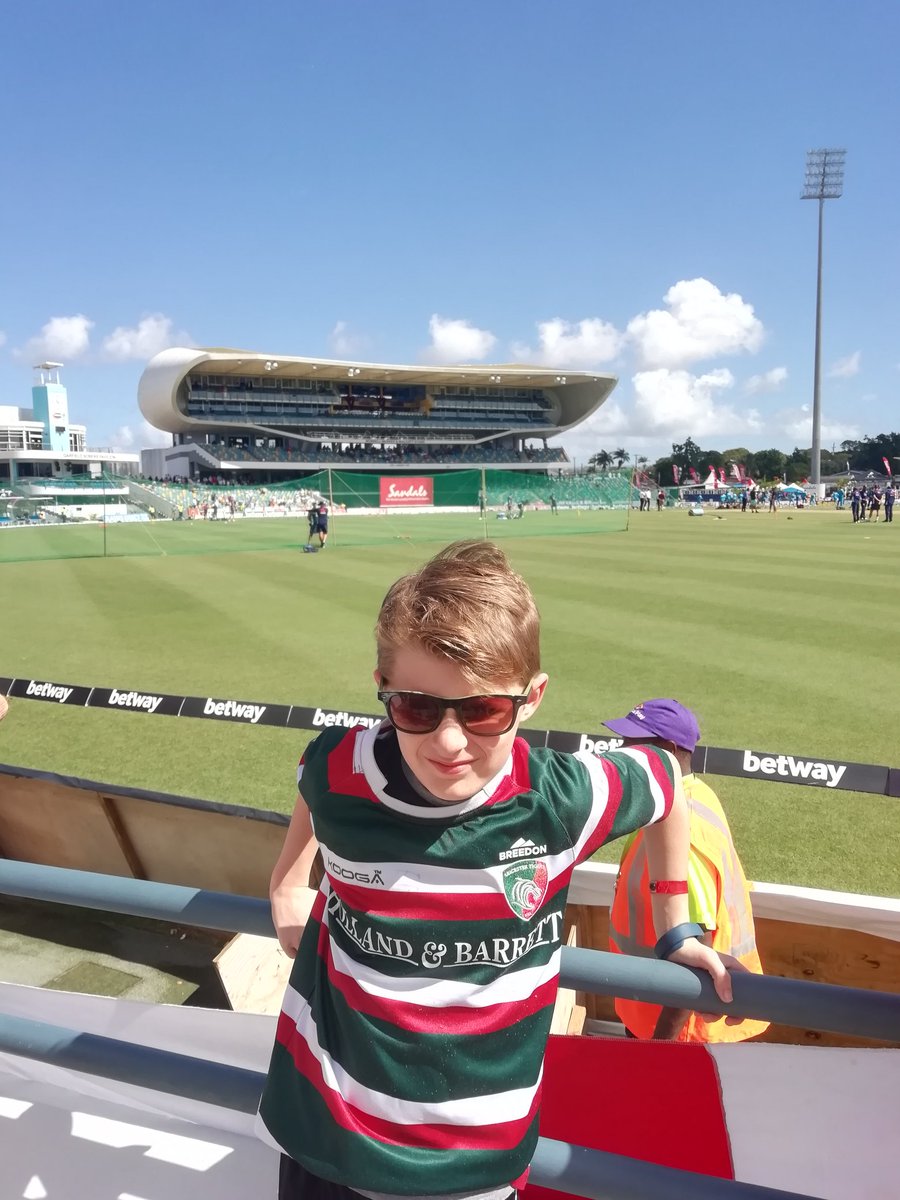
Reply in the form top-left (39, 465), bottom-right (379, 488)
top-left (631, 367), bottom-right (762, 438)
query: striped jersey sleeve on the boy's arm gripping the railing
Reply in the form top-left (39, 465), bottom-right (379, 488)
top-left (540, 746), bottom-right (682, 863)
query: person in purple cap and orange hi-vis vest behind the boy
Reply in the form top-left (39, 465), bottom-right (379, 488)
top-left (604, 700), bottom-right (768, 1042)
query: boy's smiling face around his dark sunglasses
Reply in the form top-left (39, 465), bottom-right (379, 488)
top-left (376, 643), bottom-right (547, 804)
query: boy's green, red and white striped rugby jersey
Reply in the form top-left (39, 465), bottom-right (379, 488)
top-left (259, 726), bottom-right (679, 1196)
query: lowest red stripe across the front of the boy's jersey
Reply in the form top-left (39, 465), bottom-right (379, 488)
top-left (276, 1013), bottom-right (541, 1151)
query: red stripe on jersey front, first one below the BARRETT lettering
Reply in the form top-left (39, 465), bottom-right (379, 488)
top-left (319, 940), bottom-right (559, 1037)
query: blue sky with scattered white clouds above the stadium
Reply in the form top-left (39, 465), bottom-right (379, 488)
top-left (0, 0), bottom-right (900, 457)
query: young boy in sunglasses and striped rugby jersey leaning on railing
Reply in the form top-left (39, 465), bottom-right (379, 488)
top-left (260, 541), bottom-right (731, 1200)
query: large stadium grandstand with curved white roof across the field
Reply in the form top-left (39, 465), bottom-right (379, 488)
top-left (138, 348), bottom-right (616, 484)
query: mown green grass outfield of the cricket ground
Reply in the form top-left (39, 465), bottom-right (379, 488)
top-left (0, 509), bottom-right (900, 895)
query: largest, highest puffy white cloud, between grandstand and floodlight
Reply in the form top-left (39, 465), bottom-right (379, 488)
top-left (626, 278), bottom-right (766, 368)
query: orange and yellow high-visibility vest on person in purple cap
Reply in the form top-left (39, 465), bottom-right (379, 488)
top-left (610, 775), bottom-right (769, 1042)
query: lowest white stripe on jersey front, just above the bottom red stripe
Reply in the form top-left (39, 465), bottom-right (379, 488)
top-left (282, 985), bottom-right (544, 1127)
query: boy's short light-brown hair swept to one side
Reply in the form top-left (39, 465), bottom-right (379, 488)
top-left (376, 541), bottom-right (540, 686)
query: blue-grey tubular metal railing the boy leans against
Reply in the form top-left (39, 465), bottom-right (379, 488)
top-left (0, 860), bottom-right (900, 1200)
